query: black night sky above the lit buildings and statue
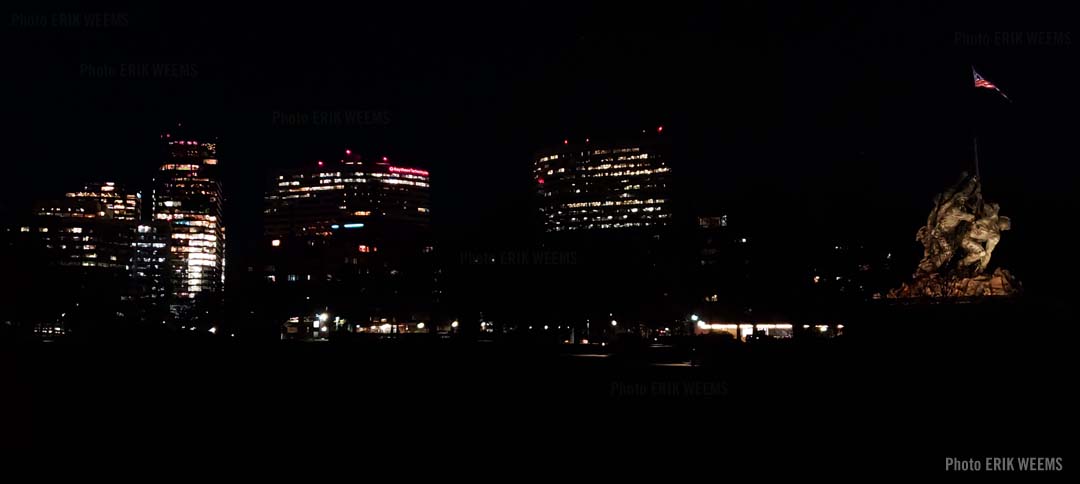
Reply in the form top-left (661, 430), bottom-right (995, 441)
top-left (0, 1), bottom-right (1080, 287)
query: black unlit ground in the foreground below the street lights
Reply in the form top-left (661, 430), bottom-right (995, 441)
top-left (0, 298), bottom-right (1077, 472)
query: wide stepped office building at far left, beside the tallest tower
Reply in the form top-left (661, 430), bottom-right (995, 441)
top-left (4, 183), bottom-right (168, 337)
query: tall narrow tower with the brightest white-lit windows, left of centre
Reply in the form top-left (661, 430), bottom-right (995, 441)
top-left (153, 130), bottom-right (225, 327)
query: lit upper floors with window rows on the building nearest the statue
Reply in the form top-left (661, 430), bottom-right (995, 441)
top-left (532, 129), bottom-right (672, 232)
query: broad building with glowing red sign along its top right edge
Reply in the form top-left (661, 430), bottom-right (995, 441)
top-left (262, 150), bottom-right (434, 337)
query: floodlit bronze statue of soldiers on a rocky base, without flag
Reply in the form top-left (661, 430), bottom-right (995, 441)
top-left (888, 170), bottom-right (1021, 299)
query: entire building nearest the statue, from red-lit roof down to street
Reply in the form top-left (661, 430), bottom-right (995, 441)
top-left (520, 127), bottom-right (678, 328)
